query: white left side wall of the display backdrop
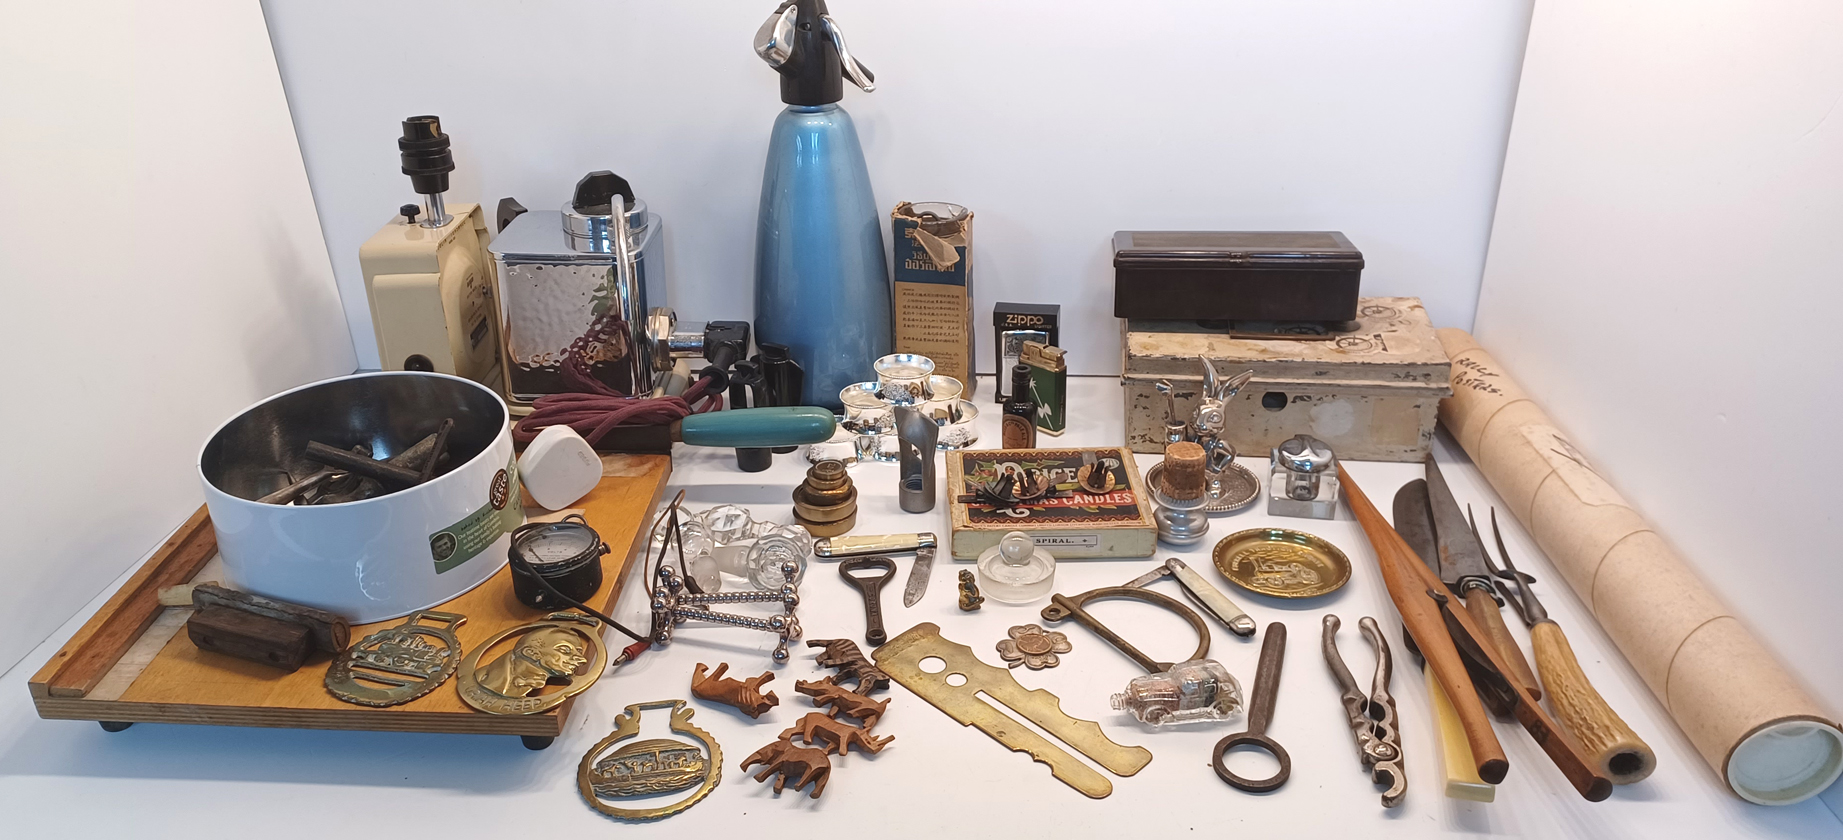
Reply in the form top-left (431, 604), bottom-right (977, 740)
top-left (0, 0), bottom-right (354, 671)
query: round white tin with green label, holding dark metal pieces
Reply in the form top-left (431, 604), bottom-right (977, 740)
top-left (199, 370), bottom-right (525, 624)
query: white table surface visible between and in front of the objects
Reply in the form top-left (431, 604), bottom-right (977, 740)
top-left (0, 378), bottom-right (1843, 840)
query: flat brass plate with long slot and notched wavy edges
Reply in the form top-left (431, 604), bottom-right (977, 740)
top-left (872, 621), bottom-right (1152, 799)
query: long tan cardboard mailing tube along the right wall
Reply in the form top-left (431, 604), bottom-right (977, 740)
top-left (1439, 330), bottom-right (1843, 805)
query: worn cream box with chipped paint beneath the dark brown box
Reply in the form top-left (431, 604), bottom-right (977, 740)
top-left (1121, 297), bottom-right (1452, 461)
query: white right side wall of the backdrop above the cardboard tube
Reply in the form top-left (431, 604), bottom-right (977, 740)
top-left (1478, 0), bottom-right (1843, 807)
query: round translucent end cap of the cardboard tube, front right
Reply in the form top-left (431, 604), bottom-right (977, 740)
top-left (1727, 720), bottom-right (1843, 805)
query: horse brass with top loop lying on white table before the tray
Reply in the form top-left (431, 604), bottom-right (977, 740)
top-left (577, 700), bottom-right (722, 822)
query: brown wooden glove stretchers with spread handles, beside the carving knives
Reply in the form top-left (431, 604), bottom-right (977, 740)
top-left (1340, 470), bottom-right (1613, 801)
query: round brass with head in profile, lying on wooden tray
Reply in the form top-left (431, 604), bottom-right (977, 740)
top-left (455, 612), bottom-right (608, 715)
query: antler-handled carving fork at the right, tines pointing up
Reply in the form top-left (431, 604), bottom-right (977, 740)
top-left (1474, 508), bottom-right (1657, 785)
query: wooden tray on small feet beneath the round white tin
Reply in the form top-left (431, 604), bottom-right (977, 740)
top-left (28, 455), bottom-right (671, 750)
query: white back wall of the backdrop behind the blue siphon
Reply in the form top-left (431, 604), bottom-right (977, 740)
top-left (264, 0), bottom-right (1530, 374)
